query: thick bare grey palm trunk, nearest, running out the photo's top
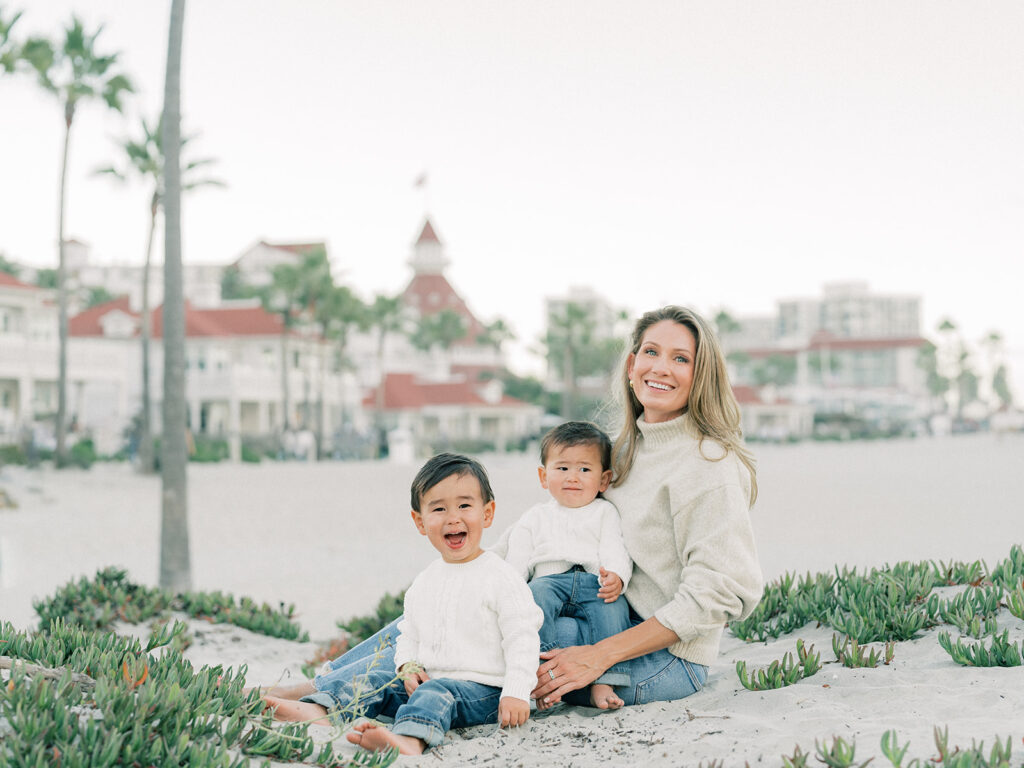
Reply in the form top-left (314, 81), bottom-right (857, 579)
top-left (160, 0), bottom-right (191, 592)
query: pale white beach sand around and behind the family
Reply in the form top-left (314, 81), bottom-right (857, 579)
top-left (0, 435), bottom-right (1024, 768)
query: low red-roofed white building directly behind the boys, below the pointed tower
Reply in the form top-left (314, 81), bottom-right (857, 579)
top-left (362, 373), bottom-right (544, 455)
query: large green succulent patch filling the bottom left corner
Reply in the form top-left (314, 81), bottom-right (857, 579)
top-left (0, 621), bottom-right (397, 768)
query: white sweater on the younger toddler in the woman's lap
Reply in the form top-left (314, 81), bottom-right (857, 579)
top-left (490, 499), bottom-right (633, 589)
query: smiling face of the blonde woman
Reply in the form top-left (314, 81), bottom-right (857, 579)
top-left (626, 319), bottom-right (697, 424)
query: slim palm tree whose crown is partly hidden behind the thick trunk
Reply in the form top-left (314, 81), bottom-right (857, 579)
top-left (97, 119), bottom-right (224, 474)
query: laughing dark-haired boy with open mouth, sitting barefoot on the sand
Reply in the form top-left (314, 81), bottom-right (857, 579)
top-left (264, 454), bottom-right (543, 755)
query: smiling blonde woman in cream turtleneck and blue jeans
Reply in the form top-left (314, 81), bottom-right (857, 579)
top-left (534, 306), bottom-right (763, 705)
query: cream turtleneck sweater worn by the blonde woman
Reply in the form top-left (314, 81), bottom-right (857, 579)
top-left (605, 414), bottom-right (764, 666)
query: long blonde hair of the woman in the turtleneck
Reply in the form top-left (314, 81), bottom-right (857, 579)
top-left (611, 306), bottom-right (758, 506)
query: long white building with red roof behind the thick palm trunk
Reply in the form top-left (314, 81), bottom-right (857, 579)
top-left (61, 297), bottom-right (358, 457)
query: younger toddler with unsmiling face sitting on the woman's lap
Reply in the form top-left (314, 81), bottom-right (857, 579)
top-left (492, 421), bottom-right (633, 710)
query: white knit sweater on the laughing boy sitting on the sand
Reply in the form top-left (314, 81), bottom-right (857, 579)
top-left (394, 552), bottom-right (544, 701)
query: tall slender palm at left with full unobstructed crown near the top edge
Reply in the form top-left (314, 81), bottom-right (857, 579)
top-left (22, 16), bottom-right (132, 467)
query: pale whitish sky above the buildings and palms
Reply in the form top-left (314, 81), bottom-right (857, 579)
top-left (0, 0), bottom-right (1024, 392)
